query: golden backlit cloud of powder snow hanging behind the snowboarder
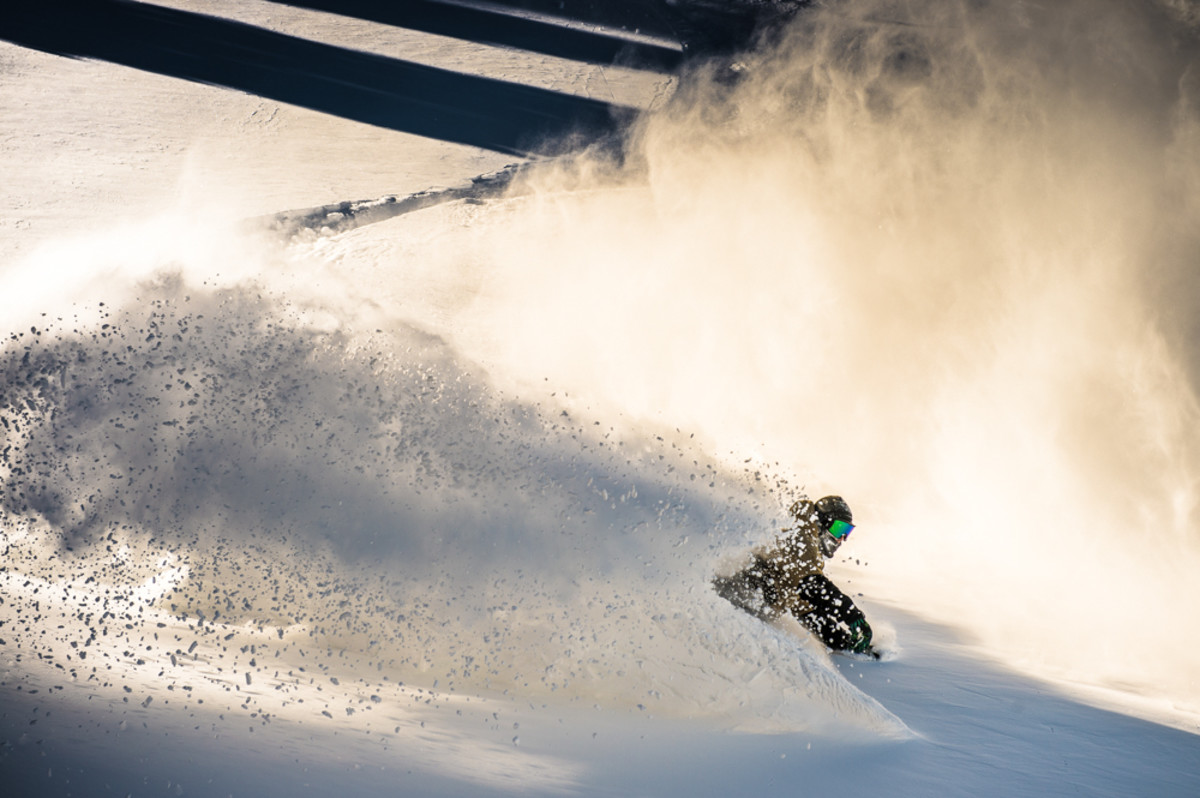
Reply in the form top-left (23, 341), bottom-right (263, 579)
top-left (398, 1), bottom-right (1200, 706)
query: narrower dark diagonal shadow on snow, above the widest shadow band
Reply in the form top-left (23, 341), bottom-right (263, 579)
top-left (260, 0), bottom-right (683, 72)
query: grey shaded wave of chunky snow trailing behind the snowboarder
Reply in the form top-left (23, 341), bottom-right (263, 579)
top-left (0, 270), bottom-right (902, 733)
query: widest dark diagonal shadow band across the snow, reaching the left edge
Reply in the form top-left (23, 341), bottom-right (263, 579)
top-left (0, 0), bottom-right (636, 155)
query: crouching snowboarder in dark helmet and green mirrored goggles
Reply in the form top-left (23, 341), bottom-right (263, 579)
top-left (713, 496), bottom-right (880, 659)
